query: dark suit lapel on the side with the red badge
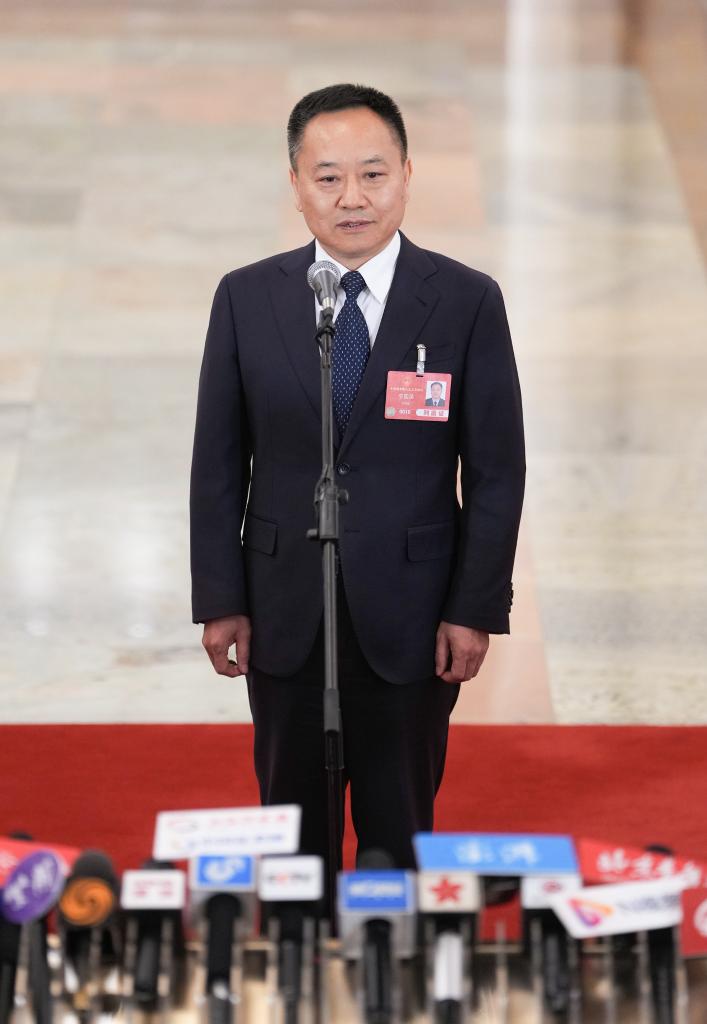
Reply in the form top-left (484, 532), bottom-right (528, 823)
top-left (338, 232), bottom-right (440, 457)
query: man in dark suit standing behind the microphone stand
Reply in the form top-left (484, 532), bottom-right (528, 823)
top-left (191, 85), bottom-right (525, 866)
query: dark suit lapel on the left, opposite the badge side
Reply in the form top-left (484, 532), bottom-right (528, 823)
top-left (269, 241), bottom-right (339, 446)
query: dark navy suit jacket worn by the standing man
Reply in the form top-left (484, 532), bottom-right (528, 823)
top-left (191, 236), bottom-right (526, 683)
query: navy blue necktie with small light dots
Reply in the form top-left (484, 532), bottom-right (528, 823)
top-left (331, 270), bottom-right (371, 436)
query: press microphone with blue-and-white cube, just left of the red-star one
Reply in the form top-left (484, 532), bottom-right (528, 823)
top-left (338, 850), bottom-right (415, 1024)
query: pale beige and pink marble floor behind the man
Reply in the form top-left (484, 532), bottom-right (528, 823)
top-left (0, 0), bottom-right (707, 724)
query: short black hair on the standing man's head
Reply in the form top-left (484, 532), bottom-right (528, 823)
top-left (287, 83), bottom-right (408, 170)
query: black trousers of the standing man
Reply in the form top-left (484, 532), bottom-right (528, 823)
top-left (247, 574), bottom-right (459, 867)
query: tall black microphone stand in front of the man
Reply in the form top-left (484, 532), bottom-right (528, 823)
top-left (306, 304), bottom-right (348, 936)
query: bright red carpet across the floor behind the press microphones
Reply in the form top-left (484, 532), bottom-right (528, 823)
top-left (0, 725), bottom-right (707, 869)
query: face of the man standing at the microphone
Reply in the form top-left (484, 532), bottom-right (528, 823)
top-left (290, 106), bottom-right (412, 270)
